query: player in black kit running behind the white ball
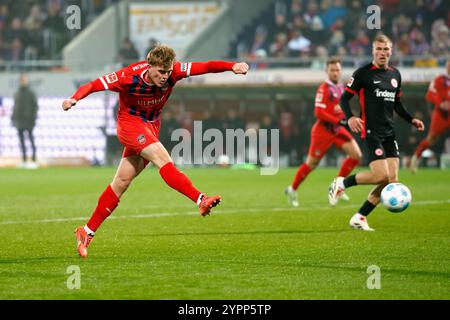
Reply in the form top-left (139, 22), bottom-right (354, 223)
top-left (328, 35), bottom-right (425, 231)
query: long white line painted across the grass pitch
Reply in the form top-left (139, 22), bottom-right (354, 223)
top-left (0, 199), bottom-right (450, 225)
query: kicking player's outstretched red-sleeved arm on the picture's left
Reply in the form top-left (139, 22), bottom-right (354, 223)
top-left (62, 70), bottom-right (125, 111)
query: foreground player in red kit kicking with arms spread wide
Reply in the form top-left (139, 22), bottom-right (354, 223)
top-left (62, 45), bottom-right (249, 257)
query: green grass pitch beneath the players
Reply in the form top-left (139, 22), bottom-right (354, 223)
top-left (0, 168), bottom-right (450, 300)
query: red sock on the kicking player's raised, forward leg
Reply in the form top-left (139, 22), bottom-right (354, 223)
top-left (159, 162), bottom-right (200, 203)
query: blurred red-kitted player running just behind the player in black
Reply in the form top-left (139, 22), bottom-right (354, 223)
top-left (285, 58), bottom-right (361, 207)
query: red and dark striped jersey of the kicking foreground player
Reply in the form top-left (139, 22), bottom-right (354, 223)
top-left (72, 61), bottom-right (234, 126)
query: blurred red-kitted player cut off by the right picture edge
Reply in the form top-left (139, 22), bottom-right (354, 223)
top-left (409, 60), bottom-right (450, 172)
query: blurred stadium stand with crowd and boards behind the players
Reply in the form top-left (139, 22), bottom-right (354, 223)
top-left (0, 0), bottom-right (450, 166)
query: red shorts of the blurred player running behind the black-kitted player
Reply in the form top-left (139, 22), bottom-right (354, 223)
top-left (308, 122), bottom-right (353, 159)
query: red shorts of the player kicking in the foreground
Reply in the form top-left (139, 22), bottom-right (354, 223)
top-left (117, 115), bottom-right (161, 158)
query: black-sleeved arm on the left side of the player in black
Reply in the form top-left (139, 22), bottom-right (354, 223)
top-left (339, 69), bottom-right (364, 133)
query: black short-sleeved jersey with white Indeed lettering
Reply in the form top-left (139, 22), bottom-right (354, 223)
top-left (345, 63), bottom-right (402, 138)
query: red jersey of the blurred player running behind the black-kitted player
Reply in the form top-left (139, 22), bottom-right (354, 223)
top-left (314, 80), bottom-right (345, 125)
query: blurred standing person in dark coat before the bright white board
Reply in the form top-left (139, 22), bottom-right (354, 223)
top-left (11, 74), bottom-right (39, 168)
